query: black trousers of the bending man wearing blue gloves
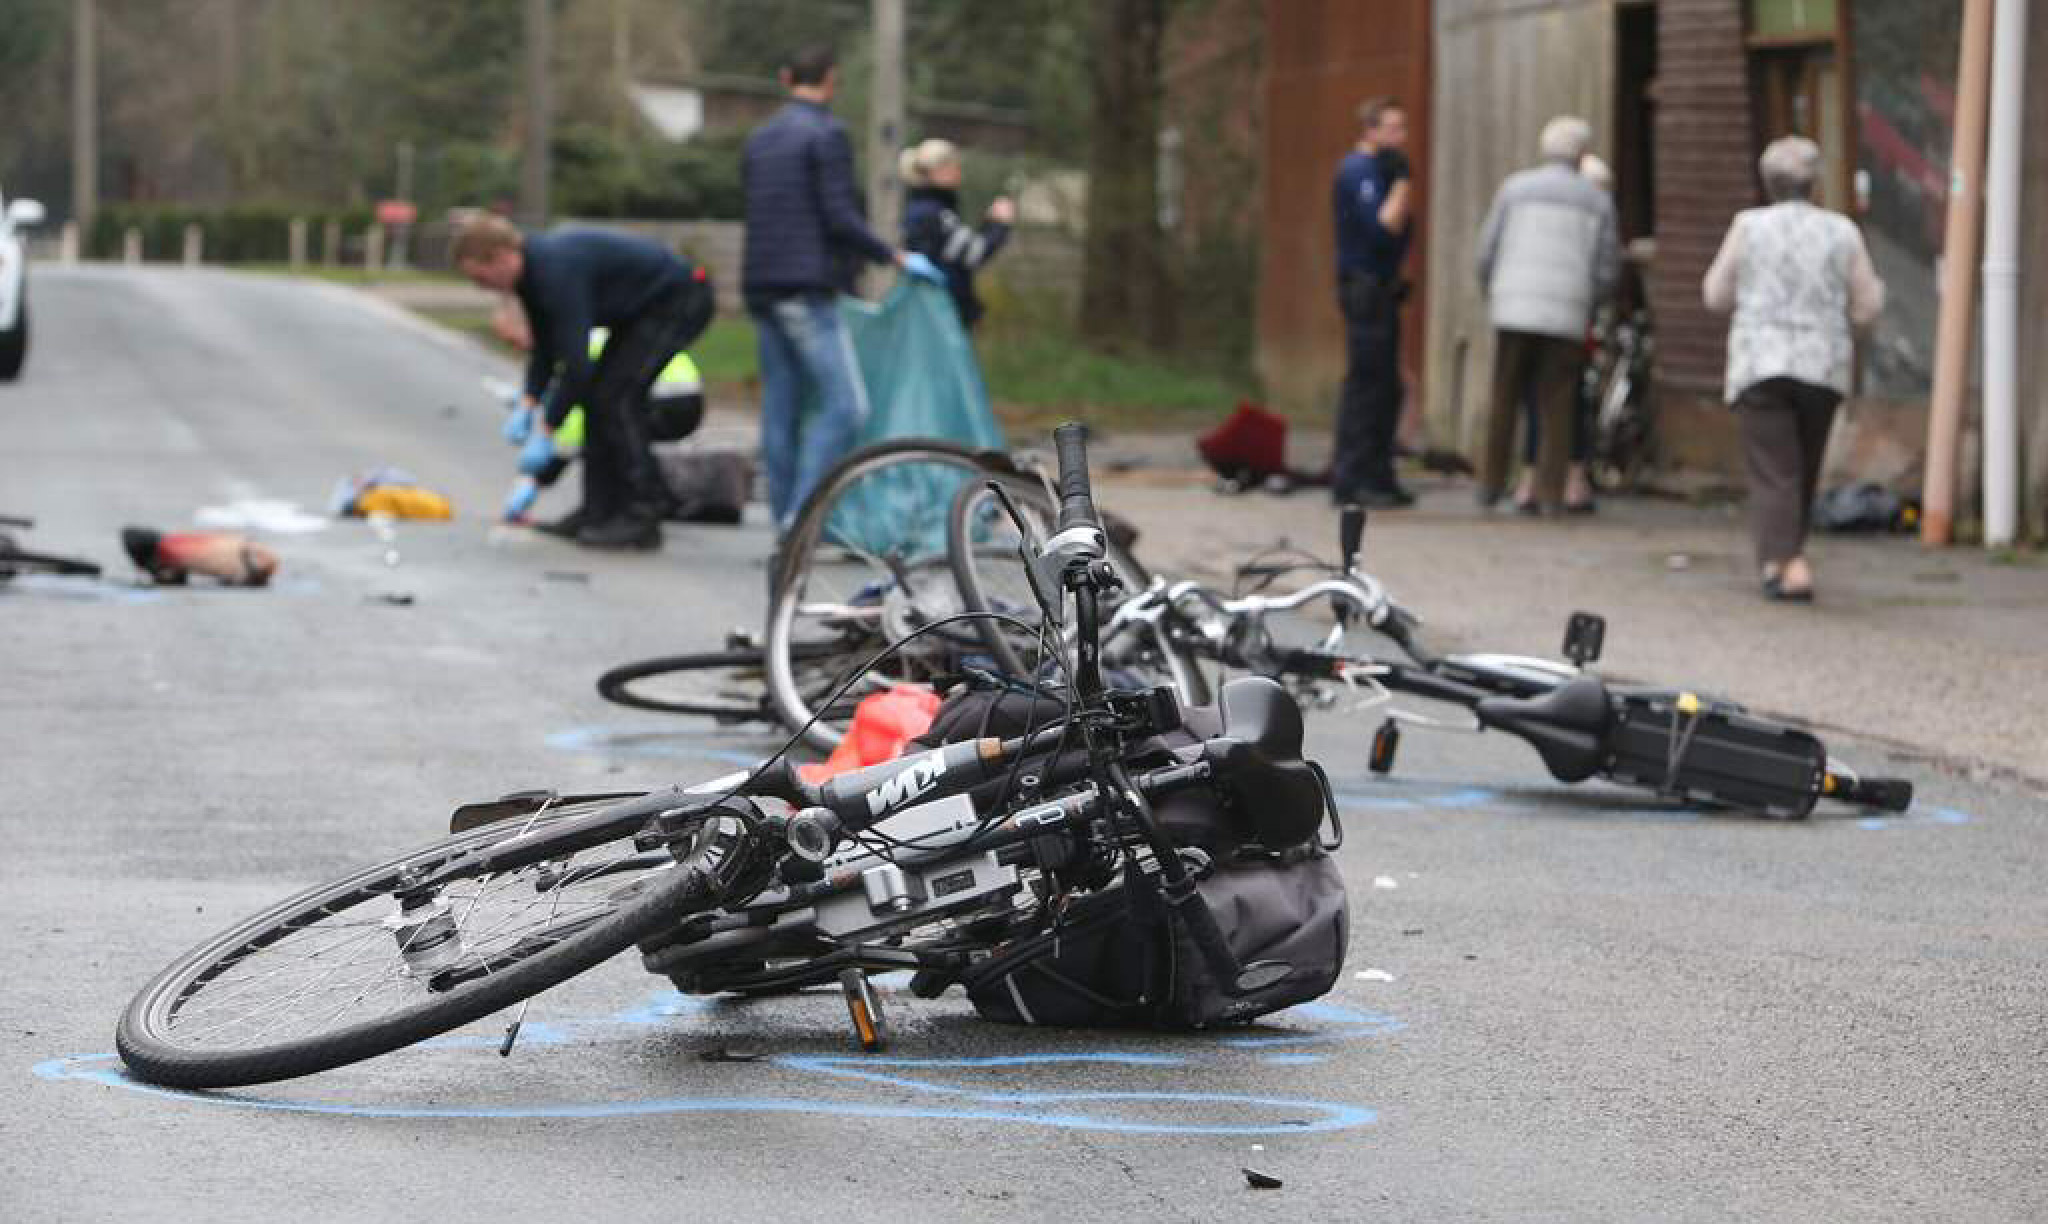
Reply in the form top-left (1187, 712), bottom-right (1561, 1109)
top-left (584, 280), bottom-right (717, 522)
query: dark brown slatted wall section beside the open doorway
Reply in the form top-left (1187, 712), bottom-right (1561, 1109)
top-left (1651, 0), bottom-right (1759, 395)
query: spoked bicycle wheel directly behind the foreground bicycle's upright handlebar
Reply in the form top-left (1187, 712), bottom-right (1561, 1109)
top-left (946, 477), bottom-right (1208, 702)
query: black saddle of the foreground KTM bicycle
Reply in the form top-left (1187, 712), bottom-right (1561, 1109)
top-left (1202, 675), bottom-right (1323, 849)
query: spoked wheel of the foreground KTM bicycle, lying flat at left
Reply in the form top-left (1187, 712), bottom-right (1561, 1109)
top-left (115, 792), bottom-right (754, 1089)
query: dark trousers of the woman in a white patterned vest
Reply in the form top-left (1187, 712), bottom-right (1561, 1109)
top-left (1735, 379), bottom-right (1841, 565)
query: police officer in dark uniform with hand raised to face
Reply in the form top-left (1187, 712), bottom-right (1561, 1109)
top-left (1329, 98), bottom-right (1415, 508)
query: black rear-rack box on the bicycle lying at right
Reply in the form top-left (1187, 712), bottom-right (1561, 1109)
top-left (1606, 692), bottom-right (1827, 821)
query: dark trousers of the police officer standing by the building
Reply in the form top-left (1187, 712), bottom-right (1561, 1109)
top-left (1329, 276), bottom-right (1401, 501)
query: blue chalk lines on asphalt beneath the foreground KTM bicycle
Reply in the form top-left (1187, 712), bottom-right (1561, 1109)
top-left (35, 991), bottom-right (1401, 1136)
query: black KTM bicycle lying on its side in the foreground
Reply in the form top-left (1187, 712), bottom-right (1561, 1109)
top-left (117, 428), bottom-right (1346, 1089)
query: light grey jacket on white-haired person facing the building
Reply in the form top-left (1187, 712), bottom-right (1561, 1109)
top-left (1479, 162), bottom-right (1622, 340)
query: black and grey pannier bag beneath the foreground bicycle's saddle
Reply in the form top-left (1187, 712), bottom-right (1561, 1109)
top-left (924, 680), bottom-right (1350, 1030)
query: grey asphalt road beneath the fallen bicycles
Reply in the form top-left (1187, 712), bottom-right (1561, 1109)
top-left (0, 268), bottom-right (2048, 1222)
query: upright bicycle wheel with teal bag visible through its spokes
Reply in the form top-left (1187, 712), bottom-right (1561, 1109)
top-left (766, 438), bottom-right (1004, 751)
